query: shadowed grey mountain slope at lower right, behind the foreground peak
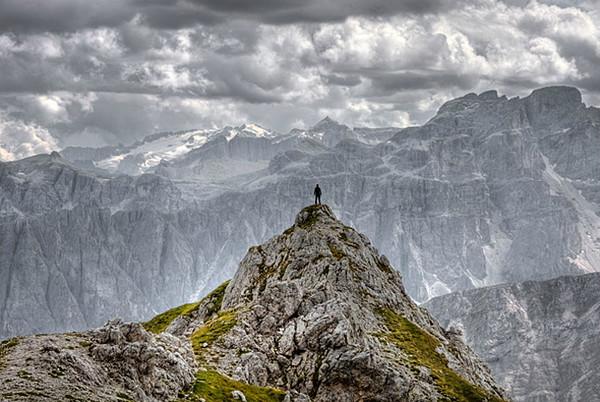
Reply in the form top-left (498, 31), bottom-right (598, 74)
top-left (425, 273), bottom-right (600, 401)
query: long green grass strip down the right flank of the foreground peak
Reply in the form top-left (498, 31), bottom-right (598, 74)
top-left (377, 308), bottom-right (503, 402)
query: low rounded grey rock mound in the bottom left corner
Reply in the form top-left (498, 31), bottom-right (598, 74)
top-left (0, 321), bottom-right (197, 402)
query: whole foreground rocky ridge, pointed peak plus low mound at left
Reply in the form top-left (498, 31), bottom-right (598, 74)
top-left (0, 205), bottom-right (505, 402)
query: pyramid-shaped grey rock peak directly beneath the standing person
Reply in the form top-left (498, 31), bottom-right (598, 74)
top-left (172, 205), bottom-right (502, 401)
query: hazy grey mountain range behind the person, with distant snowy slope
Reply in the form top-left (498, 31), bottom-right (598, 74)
top-left (0, 87), bottom-right (600, 336)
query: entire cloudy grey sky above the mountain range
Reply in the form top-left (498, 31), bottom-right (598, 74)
top-left (0, 0), bottom-right (600, 160)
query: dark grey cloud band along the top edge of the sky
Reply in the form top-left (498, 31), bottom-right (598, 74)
top-left (0, 0), bottom-right (463, 32)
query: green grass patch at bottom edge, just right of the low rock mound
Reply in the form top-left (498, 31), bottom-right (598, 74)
top-left (179, 370), bottom-right (285, 402)
